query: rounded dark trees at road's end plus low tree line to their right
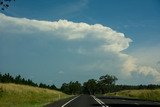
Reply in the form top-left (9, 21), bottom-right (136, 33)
top-left (60, 74), bottom-right (160, 95)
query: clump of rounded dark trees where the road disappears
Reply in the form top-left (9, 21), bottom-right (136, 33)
top-left (60, 74), bottom-right (118, 94)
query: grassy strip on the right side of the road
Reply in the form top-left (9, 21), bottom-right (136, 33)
top-left (107, 89), bottom-right (160, 102)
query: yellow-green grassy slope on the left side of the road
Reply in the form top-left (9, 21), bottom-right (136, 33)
top-left (0, 83), bottom-right (69, 107)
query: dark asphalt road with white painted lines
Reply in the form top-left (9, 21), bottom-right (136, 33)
top-left (45, 95), bottom-right (160, 107)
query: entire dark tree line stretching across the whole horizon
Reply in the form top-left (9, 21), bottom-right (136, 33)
top-left (0, 73), bottom-right (160, 95)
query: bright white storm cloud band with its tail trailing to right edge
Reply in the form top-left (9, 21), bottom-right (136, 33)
top-left (0, 13), bottom-right (160, 81)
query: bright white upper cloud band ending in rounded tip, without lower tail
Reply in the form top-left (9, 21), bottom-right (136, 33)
top-left (0, 14), bottom-right (132, 52)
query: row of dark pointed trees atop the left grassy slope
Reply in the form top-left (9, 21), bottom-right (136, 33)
top-left (0, 73), bottom-right (57, 89)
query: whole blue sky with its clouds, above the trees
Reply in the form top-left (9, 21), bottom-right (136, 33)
top-left (0, 0), bottom-right (160, 86)
